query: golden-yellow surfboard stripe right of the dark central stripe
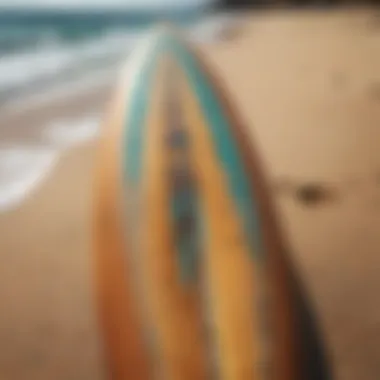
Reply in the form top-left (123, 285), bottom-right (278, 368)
top-left (182, 67), bottom-right (258, 380)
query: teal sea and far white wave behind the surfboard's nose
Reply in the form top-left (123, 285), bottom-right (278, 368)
top-left (0, 8), bottom-right (235, 108)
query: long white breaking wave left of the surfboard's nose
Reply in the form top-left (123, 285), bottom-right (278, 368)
top-left (0, 32), bottom-right (138, 103)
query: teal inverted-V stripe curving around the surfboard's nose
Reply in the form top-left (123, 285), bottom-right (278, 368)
top-left (123, 35), bottom-right (263, 260)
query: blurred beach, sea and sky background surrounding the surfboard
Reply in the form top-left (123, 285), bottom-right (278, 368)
top-left (0, 0), bottom-right (380, 380)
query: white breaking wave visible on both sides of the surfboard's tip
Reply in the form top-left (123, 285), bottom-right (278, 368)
top-left (0, 15), bottom-right (238, 107)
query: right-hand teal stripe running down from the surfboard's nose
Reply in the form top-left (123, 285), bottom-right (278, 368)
top-left (170, 38), bottom-right (262, 253)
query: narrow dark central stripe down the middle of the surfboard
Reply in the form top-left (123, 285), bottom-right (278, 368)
top-left (164, 60), bottom-right (200, 282)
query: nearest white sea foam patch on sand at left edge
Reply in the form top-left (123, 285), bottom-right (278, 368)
top-left (0, 147), bottom-right (58, 211)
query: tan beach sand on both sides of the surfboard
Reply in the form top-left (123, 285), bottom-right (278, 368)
top-left (0, 6), bottom-right (380, 380)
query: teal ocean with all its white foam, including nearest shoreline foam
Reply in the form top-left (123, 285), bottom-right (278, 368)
top-left (0, 8), bottom-right (239, 212)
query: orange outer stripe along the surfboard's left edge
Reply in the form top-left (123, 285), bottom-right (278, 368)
top-left (93, 75), bottom-right (150, 380)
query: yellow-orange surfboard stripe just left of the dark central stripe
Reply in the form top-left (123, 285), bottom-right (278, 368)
top-left (141, 57), bottom-right (207, 380)
